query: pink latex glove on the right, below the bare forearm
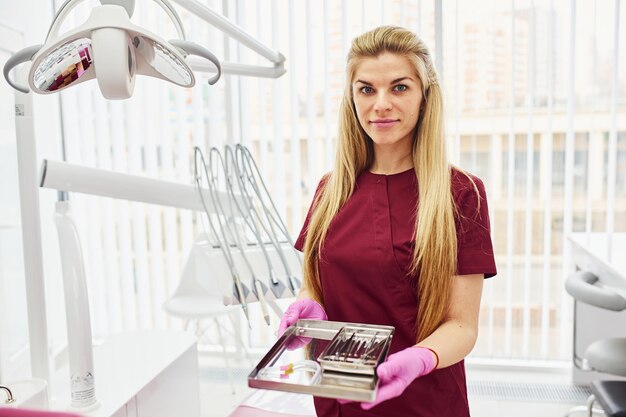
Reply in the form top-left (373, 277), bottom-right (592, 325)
top-left (339, 346), bottom-right (437, 410)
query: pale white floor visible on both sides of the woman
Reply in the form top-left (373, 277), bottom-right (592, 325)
top-left (200, 357), bottom-right (588, 417)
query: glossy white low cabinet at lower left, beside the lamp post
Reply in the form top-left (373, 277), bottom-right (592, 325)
top-left (50, 330), bottom-right (200, 417)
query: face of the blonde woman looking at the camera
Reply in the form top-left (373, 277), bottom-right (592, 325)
top-left (352, 52), bottom-right (422, 151)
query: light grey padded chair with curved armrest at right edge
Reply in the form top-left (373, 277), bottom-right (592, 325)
top-left (565, 271), bottom-right (626, 417)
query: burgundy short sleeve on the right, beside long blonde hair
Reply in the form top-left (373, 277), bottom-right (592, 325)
top-left (453, 173), bottom-right (497, 278)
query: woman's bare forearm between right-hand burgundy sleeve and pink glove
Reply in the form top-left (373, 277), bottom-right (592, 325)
top-left (417, 274), bottom-right (484, 368)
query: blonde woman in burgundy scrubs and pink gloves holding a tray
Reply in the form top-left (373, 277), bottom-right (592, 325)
top-left (279, 26), bottom-right (496, 417)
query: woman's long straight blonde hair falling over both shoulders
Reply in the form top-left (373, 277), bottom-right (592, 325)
top-left (304, 26), bottom-right (457, 341)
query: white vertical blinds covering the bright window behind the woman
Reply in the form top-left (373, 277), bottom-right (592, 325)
top-left (54, 0), bottom-right (626, 360)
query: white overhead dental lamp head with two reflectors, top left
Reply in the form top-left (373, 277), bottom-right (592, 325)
top-left (4, 0), bottom-right (221, 99)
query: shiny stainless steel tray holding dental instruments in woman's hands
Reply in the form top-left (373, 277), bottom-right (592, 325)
top-left (248, 320), bottom-right (394, 401)
